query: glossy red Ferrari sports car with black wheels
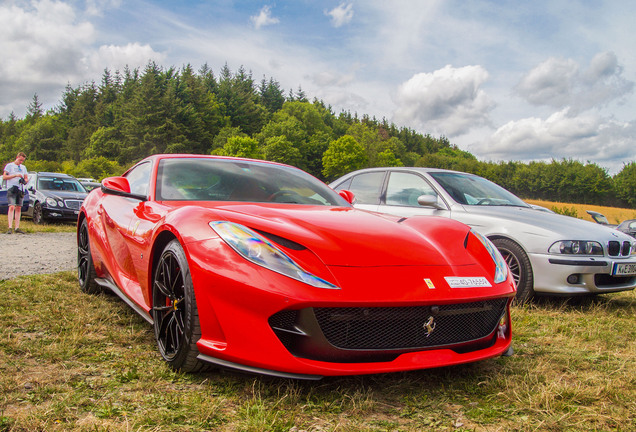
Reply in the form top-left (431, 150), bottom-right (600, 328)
top-left (77, 154), bottom-right (515, 379)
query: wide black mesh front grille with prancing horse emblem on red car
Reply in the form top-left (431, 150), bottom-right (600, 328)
top-left (269, 298), bottom-right (508, 361)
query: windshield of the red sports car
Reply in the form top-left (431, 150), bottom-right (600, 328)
top-left (156, 158), bottom-right (349, 206)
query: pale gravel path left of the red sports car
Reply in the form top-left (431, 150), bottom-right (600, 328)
top-left (0, 232), bottom-right (77, 280)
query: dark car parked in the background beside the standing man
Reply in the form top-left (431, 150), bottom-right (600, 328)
top-left (25, 172), bottom-right (88, 224)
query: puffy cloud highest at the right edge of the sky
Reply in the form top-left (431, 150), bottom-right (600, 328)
top-left (515, 52), bottom-right (634, 111)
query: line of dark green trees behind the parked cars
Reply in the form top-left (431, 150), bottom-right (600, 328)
top-left (0, 62), bottom-right (636, 208)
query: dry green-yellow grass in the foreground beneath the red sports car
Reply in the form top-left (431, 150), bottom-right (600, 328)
top-left (0, 272), bottom-right (636, 432)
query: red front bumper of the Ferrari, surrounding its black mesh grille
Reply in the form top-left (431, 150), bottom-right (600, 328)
top-left (189, 242), bottom-right (514, 379)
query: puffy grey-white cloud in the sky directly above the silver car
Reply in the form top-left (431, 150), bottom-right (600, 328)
top-left (394, 66), bottom-right (494, 137)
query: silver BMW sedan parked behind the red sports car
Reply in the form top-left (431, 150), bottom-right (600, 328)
top-left (330, 168), bottom-right (636, 303)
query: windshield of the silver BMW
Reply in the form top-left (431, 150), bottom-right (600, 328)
top-left (430, 172), bottom-right (528, 207)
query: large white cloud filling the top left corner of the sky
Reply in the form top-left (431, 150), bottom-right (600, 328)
top-left (0, 0), bottom-right (165, 118)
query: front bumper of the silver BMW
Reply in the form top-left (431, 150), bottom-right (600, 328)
top-left (529, 254), bottom-right (636, 295)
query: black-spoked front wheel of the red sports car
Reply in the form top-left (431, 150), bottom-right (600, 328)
top-left (152, 239), bottom-right (207, 372)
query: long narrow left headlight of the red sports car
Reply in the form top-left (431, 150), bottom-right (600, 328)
top-left (210, 221), bottom-right (340, 289)
